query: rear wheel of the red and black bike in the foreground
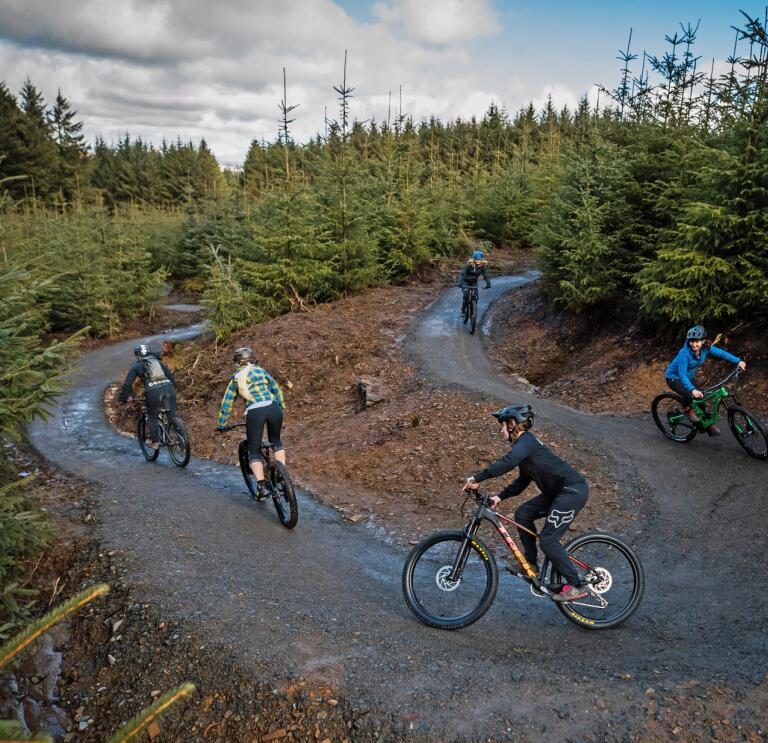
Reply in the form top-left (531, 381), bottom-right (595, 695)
top-left (542, 534), bottom-right (645, 630)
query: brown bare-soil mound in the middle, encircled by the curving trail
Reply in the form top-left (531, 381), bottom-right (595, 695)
top-left (108, 256), bottom-right (633, 542)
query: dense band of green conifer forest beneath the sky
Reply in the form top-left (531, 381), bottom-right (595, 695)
top-left (0, 8), bottom-right (768, 346)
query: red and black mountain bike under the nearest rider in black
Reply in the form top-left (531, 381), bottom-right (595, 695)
top-left (403, 491), bottom-right (645, 630)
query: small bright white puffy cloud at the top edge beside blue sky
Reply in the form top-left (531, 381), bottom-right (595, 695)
top-left (373, 0), bottom-right (500, 44)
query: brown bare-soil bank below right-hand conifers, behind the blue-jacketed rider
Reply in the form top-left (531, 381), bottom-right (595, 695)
top-left (487, 284), bottom-right (768, 415)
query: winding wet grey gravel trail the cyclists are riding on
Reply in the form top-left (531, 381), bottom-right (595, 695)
top-left (31, 275), bottom-right (768, 740)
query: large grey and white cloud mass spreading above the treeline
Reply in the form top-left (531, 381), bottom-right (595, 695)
top-left (0, 0), bottom-right (578, 163)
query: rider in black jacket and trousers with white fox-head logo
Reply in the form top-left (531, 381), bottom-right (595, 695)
top-left (466, 405), bottom-right (589, 602)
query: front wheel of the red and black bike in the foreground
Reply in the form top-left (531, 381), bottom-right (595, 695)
top-left (403, 531), bottom-right (499, 630)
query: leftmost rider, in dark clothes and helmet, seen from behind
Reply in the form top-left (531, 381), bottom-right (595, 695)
top-left (117, 343), bottom-right (181, 449)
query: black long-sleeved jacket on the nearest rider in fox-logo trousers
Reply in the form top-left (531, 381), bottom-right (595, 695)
top-left (475, 431), bottom-right (587, 500)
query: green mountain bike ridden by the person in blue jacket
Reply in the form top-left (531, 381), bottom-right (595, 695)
top-left (651, 368), bottom-right (768, 459)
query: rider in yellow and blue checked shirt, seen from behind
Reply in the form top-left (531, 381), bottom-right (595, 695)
top-left (216, 347), bottom-right (285, 498)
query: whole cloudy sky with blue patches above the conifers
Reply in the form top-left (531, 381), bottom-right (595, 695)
top-left (0, 0), bottom-right (762, 164)
